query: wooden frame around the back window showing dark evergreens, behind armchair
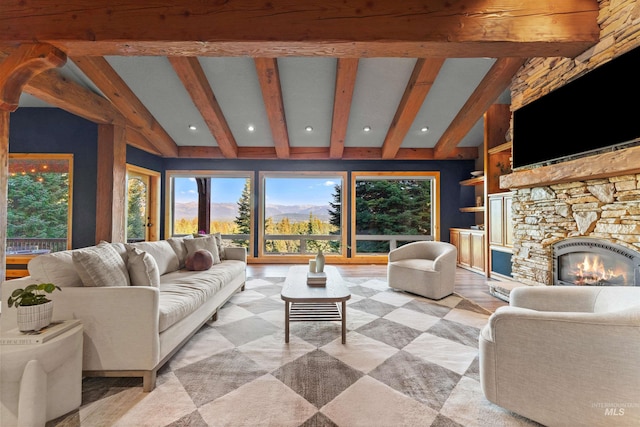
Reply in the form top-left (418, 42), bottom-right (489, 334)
top-left (350, 171), bottom-right (440, 262)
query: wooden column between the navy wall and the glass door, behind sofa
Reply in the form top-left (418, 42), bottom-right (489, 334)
top-left (96, 125), bottom-right (127, 243)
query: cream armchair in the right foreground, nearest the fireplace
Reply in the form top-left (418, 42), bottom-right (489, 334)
top-left (479, 286), bottom-right (640, 426)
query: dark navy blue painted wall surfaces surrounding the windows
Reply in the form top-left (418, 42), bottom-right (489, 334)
top-left (9, 108), bottom-right (475, 252)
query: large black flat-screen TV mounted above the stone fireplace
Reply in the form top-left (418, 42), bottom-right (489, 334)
top-left (512, 47), bottom-right (640, 169)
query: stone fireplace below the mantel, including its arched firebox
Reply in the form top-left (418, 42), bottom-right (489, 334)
top-left (504, 173), bottom-right (640, 285)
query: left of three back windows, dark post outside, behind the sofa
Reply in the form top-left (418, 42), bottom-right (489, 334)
top-left (166, 171), bottom-right (253, 248)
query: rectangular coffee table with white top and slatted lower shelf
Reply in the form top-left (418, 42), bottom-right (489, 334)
top-left (280, 265), bottom-right (351, 344)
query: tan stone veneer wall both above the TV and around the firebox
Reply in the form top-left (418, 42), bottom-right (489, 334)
top-left (511, 0), bottom-right (640, 285)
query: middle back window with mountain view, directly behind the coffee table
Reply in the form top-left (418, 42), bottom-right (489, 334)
top-left (260, 172), bottom-right (346, 255)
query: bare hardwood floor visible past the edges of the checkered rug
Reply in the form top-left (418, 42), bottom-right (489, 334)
top-left (247, 264), bottom-right (509, 311)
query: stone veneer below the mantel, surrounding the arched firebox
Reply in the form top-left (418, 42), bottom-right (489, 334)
top-left (512, 175), bottom-right (640, 285)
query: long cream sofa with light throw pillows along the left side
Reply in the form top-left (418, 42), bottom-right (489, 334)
top-left (0, 235), bottom-right (247, 391)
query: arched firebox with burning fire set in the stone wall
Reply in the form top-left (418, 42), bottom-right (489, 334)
top-left (553, 238), bottom-right (640, 286)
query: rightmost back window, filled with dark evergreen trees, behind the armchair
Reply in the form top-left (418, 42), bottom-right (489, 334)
top-left (351, 172), bottom-right (440, 255)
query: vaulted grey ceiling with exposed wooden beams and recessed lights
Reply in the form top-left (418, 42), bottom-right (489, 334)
top-left (0, 0), bottom-right (599, 159)
